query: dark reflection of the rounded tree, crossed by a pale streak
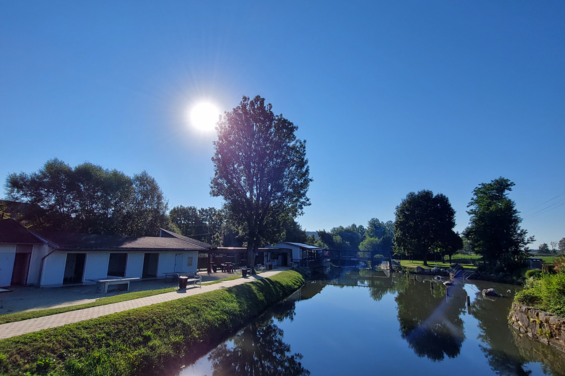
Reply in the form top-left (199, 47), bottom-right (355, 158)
top-left (396, 279), bottom-right (465, 361)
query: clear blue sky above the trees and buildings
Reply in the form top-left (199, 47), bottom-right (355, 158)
top-left (0, 0), bottom-right (565, 245)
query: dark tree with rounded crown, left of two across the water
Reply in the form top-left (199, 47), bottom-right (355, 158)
top-left (394, 190), bottom-right (455, 265)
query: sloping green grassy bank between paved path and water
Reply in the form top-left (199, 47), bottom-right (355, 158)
top-left (0, 271), bottom-right (304, 375)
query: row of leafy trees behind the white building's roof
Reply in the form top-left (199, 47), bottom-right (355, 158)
top-left (5, 159), bottom-right (171, 236)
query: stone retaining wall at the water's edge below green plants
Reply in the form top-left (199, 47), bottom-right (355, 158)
top-left (508, 303), bottom-right (565, 352)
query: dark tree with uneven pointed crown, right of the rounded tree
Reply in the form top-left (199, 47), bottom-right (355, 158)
top-left (463, 177), bottom-right (535, 265)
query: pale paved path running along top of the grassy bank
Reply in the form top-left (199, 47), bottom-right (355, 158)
top-left (0, 270), bottom-right (281, 339)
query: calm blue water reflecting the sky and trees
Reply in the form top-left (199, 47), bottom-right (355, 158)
top-left (179, 269), bottom-right (565, 376)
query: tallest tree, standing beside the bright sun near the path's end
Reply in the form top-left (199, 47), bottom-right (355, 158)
top-left (210, 96), bottom-right (312, 267)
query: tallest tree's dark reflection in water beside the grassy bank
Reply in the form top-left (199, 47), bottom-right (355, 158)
top-left (208, 301), bottom-right (310, 376)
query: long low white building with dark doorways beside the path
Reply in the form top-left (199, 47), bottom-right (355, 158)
top-left (0, 219), bottom-right (212, 287)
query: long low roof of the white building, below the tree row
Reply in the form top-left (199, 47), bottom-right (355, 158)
top-left (34, 231), bottom-right (212, 251)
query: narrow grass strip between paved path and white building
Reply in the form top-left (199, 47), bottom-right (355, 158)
top-left (0, 274), bottom-right (241, 324)
